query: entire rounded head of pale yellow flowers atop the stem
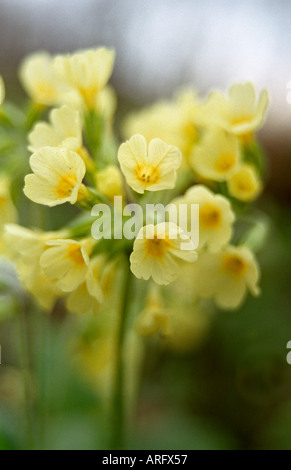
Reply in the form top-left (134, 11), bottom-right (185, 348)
top-left (0, 48), bottom-right (268, 358)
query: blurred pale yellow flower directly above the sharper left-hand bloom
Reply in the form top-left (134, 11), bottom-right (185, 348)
top-left (28, 105), bottom-right (82, 152)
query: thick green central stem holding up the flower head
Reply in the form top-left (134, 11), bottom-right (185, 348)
top-left (110, 261), bottom-right (132, 450)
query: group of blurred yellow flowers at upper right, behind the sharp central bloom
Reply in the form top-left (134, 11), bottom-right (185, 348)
top-left (123, 83), bottom-right (268, 202)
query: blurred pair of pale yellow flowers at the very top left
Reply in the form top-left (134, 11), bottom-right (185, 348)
top-left (20, 48), bottom-right (114, 109)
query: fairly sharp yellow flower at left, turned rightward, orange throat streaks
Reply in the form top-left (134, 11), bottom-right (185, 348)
top-left (24, 147), bottom-right (86, 207)
